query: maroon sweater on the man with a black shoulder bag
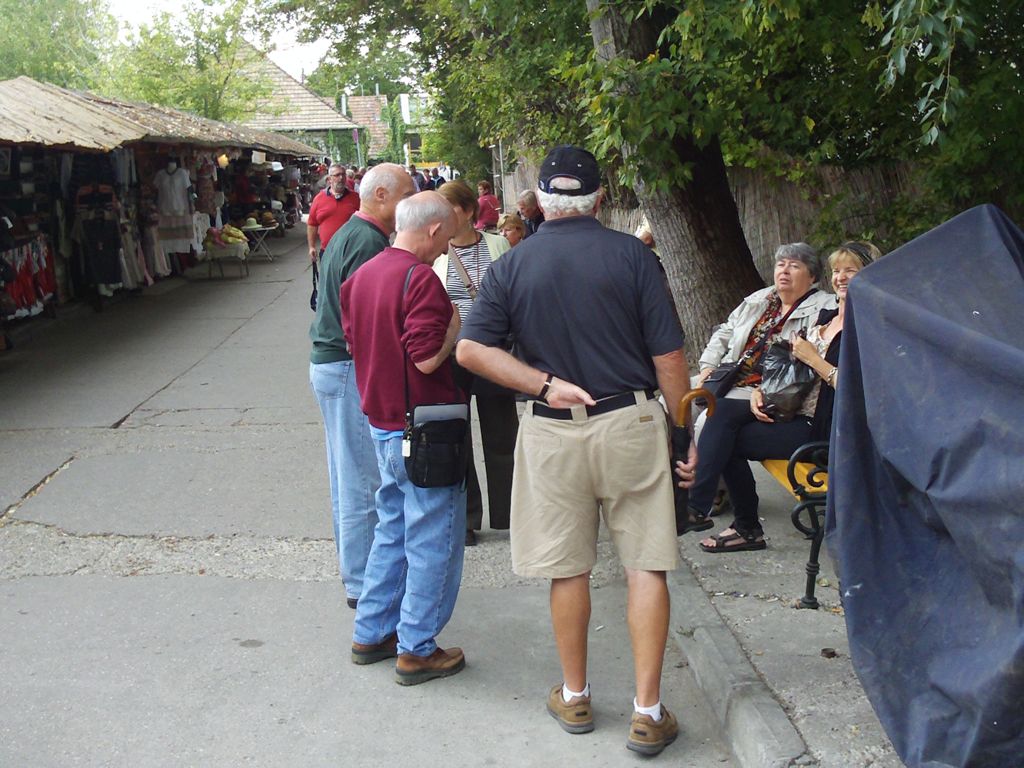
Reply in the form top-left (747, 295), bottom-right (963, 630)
top-left (340, 248), bottom-right (466, 430)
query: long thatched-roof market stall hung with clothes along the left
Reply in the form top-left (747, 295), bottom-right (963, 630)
top-left (0, 77), bottom-right (315, 349)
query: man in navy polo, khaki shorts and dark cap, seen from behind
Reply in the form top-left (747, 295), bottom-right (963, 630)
top-left (457, 145), bottom-right (696, 755)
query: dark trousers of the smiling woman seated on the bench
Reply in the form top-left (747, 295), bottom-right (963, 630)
top-left (690, 397), bottom-right (811, 536)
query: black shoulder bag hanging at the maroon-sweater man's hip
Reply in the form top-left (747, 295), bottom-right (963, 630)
top-left (401, 264), bottom-right (470, 488)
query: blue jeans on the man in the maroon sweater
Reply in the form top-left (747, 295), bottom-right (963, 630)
top-left (353, 437), bottom-right (466, 656)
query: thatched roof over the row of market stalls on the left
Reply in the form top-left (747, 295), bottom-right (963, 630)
top-left (0, 77), bottom-right (318, 157)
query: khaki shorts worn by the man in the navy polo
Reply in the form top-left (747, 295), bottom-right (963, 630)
top-left (511, 392), bottom-right (679, 579)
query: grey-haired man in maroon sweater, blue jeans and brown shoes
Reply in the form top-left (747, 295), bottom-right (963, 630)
top-left (340, 191), bottom-right (466, 685)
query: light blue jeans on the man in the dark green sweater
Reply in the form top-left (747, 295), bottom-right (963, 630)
top-left (309, 360), bottom-right (381, 599)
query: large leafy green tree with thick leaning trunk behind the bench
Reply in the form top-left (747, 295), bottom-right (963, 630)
top-left (276, 0), bottom-right (1024, 348)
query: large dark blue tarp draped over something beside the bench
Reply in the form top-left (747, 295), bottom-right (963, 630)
top-left (826, 206), bottom-right (1024, 768)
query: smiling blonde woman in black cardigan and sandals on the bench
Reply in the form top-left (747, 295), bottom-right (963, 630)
top-left (691, 243), bottom-right (881, 553)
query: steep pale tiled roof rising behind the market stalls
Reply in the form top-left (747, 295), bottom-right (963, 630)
top-left (246, 48), bottom-right (356, 131)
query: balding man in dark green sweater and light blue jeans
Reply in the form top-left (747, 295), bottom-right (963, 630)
top-left (309, 163), bottom-right (416, 608)
